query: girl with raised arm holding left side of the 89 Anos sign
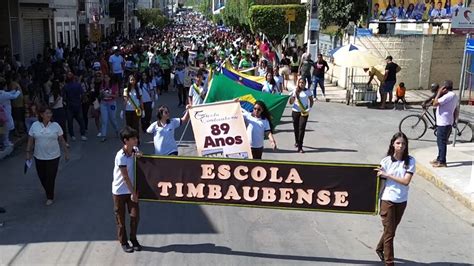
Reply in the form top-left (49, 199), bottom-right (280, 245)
top-left (146, 105), bottom-right (190, 156)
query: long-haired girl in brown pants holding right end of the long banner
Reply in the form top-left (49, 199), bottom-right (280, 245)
top-left (376, 132), bottom-right (416, 265)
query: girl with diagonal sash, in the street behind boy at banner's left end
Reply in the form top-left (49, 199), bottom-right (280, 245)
top-left (123, 74), bottom-right (144, 139)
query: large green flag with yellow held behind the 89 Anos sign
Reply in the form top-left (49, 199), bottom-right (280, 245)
top-left (205, 73), bottom-right (289, 127)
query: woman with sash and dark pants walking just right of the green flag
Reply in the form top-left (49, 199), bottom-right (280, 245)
top-left (290, 78), bottom-right (314, 153)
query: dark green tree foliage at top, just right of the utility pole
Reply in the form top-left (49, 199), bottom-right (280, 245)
top-left (319, 0), bottom-right (368, 30)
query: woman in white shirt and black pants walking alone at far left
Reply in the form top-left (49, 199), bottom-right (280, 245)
top-left (26, 107), bottom-right (69, 205)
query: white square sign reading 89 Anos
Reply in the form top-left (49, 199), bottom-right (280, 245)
top-left (189, 101), bottom-right (252, 159)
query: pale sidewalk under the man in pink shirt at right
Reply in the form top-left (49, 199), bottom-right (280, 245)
top-left (411, 143), bottom-right (474, 210)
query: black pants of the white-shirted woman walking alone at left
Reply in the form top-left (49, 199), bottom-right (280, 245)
top-left (35, 157), bottom-right (59, 200)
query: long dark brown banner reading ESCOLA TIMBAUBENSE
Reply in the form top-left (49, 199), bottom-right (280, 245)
top-left (135, 156), bottom-right (379, 214)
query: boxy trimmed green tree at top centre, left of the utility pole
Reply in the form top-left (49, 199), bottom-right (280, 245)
top-left (249, 5), bottom-right (306, 42)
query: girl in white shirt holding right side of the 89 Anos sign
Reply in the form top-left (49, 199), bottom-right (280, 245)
top-left (242, 101), bottom-right (277, 159)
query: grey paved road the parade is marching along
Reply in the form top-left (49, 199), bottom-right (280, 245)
top-left (0, 94), bottom-right (474, 265)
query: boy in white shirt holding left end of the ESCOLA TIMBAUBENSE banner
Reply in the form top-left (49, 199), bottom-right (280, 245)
top-left (112, 126), bottom-right (142, 253)
